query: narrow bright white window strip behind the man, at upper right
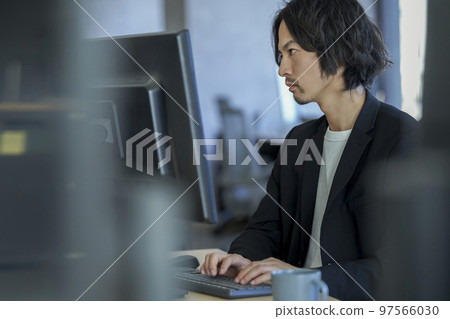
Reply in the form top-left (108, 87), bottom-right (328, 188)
top-left (399, 0), bottom-right (427, 120)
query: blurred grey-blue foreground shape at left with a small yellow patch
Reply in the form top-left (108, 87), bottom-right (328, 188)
top-left (0, 0), bottom-right (181, 300)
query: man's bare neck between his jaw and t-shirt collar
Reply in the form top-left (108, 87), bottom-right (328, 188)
top-left (317, 86), bottom-right (366, 131)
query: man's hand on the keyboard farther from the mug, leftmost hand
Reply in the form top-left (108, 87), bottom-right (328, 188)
top-left (200, 253), bottom-right (251, 277)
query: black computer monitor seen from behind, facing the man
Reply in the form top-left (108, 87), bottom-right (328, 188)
top-left (85, 30), bottom-right (217, 223)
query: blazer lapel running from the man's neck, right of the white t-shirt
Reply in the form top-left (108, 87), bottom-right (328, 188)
top-left (325, 91), bottom-right (380, 212)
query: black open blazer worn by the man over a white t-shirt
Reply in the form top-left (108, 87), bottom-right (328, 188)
top-left (229, 91), bottom-right (418, 300)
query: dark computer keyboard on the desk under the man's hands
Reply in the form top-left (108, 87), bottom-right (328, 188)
top-left (172, 269), bottom-right (272, 299)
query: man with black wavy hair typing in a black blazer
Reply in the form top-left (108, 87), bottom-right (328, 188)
top-left (201, 0), bottom-right (417, 300)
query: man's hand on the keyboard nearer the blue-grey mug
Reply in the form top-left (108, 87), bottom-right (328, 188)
top-left (234, 257), bottom-right (297, 285)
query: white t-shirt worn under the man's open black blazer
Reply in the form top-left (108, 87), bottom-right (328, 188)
top-left (304, 127), bottom-right (352, 268)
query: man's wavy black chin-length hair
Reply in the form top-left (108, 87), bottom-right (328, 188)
top-left (272, 0), bottom-right (392, 90)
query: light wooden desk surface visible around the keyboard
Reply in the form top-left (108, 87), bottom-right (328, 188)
top-left (172, 248), bottom-right (337, 301)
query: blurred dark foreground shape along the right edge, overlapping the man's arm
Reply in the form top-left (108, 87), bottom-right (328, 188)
top-left (375, 0), bottom-right (450, 300)
